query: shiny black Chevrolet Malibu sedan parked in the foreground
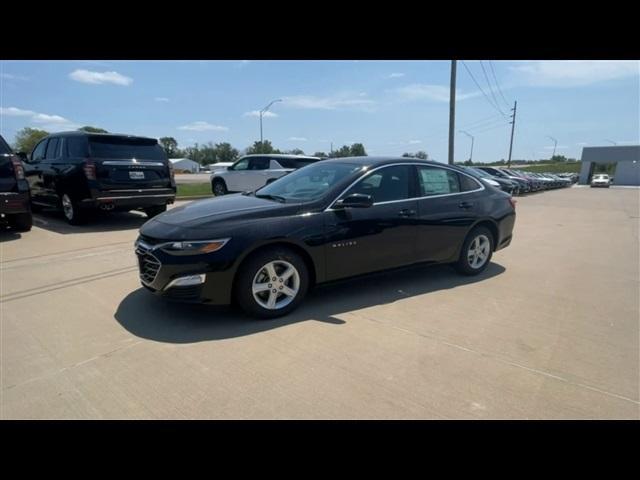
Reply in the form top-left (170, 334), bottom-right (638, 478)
top-left (135, 157), bottom-right (515, 318)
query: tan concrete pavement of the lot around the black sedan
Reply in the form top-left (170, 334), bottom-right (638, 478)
top-left (0, 188), bottom-right (640, 419)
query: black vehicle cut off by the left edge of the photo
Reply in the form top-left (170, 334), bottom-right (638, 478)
top-left (0, 136), bottom-right (33, 232)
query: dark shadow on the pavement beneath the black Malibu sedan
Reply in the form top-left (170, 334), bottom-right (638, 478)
top-left (114, 263), bottom-right (505, 343)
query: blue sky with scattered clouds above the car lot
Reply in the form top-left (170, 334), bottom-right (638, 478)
top-left (0, 60), bottom-right (640, 162)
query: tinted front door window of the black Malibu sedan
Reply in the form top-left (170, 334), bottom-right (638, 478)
top-left (343, 165), bottom-right (411, 203)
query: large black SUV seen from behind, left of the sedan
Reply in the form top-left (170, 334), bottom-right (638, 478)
top-left (25, 132), bottom-right (176, 225)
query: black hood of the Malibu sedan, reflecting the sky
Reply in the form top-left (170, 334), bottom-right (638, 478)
top-left (140, 194), bottom-right (300, 239)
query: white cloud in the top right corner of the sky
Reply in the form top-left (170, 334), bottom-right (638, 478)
top-left (510, 60), bottom-right (640, 87)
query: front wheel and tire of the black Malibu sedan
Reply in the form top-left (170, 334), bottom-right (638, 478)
top-left (234, 247), bottom-right (309, 318)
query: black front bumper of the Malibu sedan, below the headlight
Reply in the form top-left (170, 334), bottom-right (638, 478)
top-left (136, 241), bottom-right (233, 305)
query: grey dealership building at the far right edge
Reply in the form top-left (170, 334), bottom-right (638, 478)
top-left (579, 145), bottom-right (640, 185)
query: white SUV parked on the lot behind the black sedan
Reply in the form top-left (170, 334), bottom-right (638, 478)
top-left (211, 153), bottom-right (320, 195)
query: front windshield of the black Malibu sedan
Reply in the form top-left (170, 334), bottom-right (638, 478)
top-left (255, 161), bottom-right (363, 203)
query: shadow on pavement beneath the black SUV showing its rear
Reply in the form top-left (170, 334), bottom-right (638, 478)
top-left (33, 210), bottom-right (149, 235)
